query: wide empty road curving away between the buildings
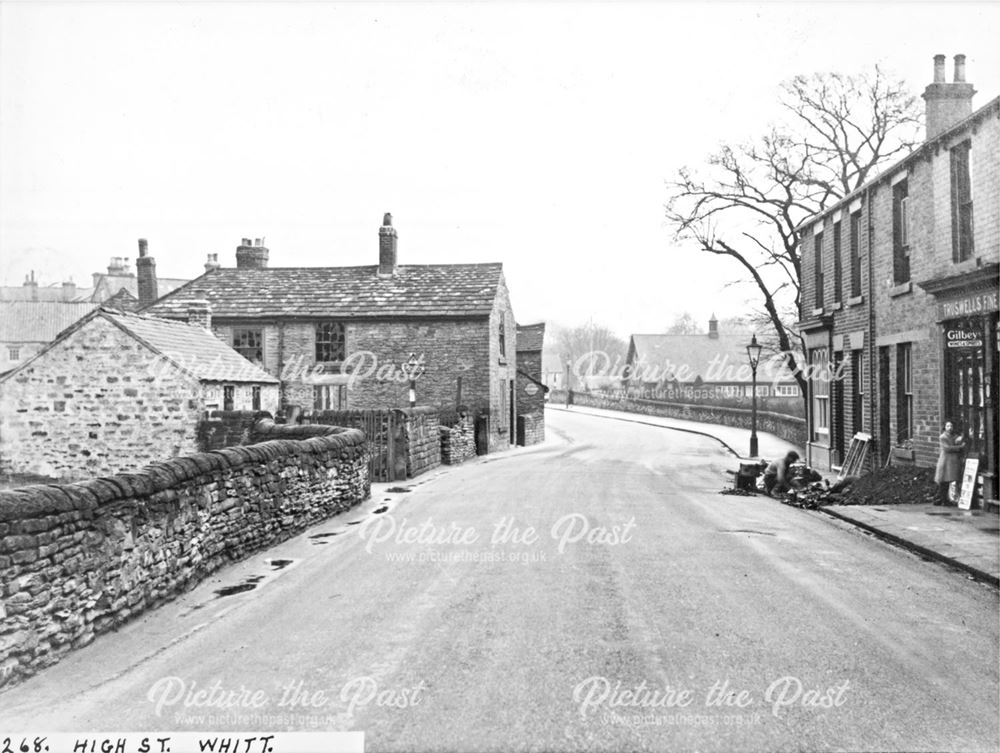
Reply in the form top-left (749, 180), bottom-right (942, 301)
top-left (0, 412), bottom-right (1000, 751)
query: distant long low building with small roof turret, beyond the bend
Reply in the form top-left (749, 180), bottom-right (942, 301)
top-left (624, 316), bottom-right (802, 402)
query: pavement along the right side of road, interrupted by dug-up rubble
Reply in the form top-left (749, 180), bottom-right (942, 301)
top-left (546, 404), bottom-right (1000, 587)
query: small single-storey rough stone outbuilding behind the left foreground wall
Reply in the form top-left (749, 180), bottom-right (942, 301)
top-left (0, 308), bottom-right (278, 479)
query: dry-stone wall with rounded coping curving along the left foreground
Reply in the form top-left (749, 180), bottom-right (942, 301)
top-left (0, 426), bottom-right (371, 685)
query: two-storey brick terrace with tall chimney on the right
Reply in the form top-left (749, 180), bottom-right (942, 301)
top-left (800, 55), bottom-right (1000, 500)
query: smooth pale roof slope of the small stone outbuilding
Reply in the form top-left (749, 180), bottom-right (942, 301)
top-left (100, 309), bottom-right (278, 384)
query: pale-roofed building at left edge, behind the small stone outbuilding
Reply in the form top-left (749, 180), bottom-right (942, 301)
top-left (0, 301), bottom-right (97, 374)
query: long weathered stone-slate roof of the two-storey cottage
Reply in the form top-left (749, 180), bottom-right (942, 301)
top-left (145, 263), bottom-right (503, 319)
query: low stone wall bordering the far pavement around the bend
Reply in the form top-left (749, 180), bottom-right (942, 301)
top-left (549, 390), bottom-right (806, 448)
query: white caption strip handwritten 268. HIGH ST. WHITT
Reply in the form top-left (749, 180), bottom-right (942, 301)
top-left (0, 732), bottom-right (365, 753)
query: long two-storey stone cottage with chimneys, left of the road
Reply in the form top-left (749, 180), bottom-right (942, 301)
top-left (145, 214), bottom-right (517, 451)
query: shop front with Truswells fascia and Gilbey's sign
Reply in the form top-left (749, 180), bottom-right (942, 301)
top-left (921, 264), bottom-right (1000, 501)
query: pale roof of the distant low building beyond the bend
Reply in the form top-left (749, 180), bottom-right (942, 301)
top-left (629, 332), bottom-right (794, 384)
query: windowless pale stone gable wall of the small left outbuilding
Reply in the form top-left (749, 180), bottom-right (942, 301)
top-left (0, 317), bottom-right (203, 480)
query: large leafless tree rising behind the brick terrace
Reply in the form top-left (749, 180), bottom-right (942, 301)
top-left (666, 67), bottom-right (921, 406)
